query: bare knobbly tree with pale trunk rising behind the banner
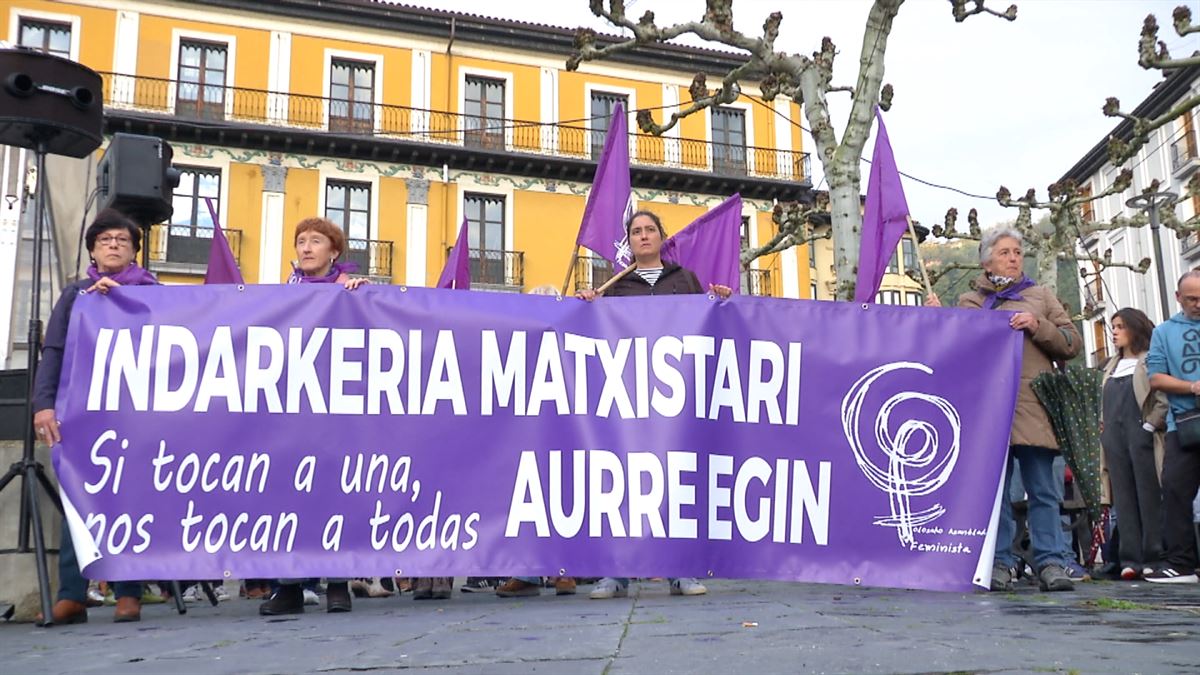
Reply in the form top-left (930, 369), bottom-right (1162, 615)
top-left (566, 0), bottom-right (1016, 299)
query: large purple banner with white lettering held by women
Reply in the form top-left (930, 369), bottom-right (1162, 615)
top-left (54, 285), bottom-right (1021, 590)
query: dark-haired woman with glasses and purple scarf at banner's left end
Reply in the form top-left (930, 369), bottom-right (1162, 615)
top-left (32, 209), bottom-right (158, 623)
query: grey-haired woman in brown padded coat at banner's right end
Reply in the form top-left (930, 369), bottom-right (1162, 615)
top-left (930, 227), bottom-right (1084, 591)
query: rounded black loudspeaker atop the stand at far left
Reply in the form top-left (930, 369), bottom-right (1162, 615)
top-left (0, 49), bottom-right (104, 157)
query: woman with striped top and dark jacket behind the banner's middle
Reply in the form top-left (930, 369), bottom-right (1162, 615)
top-left (576, 211), bottom-right (733, 599)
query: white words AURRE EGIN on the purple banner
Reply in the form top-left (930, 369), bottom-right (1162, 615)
top-left (504, 450), bottom-right (832, 546)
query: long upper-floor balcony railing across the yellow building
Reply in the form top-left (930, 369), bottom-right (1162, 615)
top-left (101, 73), bottom-right (810, 181)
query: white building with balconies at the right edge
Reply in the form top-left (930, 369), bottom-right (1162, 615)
top-left (1063, 66), bottom-right (1200, 366)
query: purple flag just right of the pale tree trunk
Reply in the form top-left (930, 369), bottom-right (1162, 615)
top-left (854, 108), bottom-right (908, 303)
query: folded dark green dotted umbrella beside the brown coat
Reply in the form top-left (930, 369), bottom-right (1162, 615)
top-left (1033, 365), bottom-right (1103, 525)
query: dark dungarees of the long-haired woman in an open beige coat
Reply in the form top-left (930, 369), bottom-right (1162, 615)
top-left (1100, 378), bottom-right (1163, 562)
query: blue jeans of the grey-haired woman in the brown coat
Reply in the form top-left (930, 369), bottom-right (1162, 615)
top-left (996, 446), bottom-right (1066, 571)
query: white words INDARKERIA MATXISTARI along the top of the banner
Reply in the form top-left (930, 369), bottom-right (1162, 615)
top-left (88, 325), bottom-right (803, 426)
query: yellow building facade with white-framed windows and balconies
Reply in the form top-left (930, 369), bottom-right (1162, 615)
top-left (0, 0), bottom-right (832, 299)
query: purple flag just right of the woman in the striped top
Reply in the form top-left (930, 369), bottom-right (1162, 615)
top-left (662, 195), bottom-right (742, 293)
